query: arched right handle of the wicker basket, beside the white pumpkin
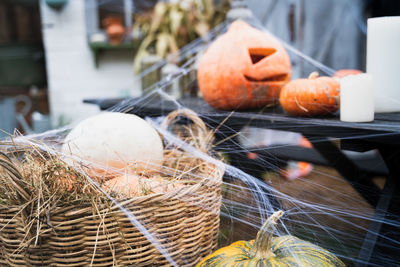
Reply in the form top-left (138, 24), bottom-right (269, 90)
top-left (161, 108), bottom-right (212, 152)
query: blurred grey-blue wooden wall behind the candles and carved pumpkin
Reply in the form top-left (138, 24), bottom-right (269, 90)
top-left (247, 0), bottom-right (367, 76)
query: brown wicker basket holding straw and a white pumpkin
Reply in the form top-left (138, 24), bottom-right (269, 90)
top-left (0, 110), bottom-right (223, 267)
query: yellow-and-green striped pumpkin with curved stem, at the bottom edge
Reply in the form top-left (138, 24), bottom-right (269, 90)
top-left (197, 211), bottom-right (345, 267)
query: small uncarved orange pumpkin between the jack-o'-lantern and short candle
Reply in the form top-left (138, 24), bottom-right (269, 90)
top-left (279, 72), bottom-right (340, 116)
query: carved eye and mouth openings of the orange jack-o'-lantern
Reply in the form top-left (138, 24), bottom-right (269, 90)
top-left (244, 48), bottom-right (288, 82)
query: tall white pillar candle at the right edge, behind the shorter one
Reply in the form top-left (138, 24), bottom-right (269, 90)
top-left (367, 17), bottom-right (400, 112)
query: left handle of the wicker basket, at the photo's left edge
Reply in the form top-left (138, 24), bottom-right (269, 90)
top-left (0, 152), bottom-right (31, 202)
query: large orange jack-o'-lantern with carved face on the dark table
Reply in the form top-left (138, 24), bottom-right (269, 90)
top-left (197, 20), bottom-right (292, 110)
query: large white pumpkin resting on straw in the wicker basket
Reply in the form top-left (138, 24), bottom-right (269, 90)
top-left (62, 112), bottom-right (163, 177)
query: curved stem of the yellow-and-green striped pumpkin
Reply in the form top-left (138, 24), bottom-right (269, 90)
top-left (250, 210), bottom-right (283, 259)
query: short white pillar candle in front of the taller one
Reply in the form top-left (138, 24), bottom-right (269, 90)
top-left (340, 73), bottom-right (374, 122)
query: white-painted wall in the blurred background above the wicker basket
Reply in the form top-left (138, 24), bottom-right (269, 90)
top-left (40, 0), bottom-right (140, 127)
